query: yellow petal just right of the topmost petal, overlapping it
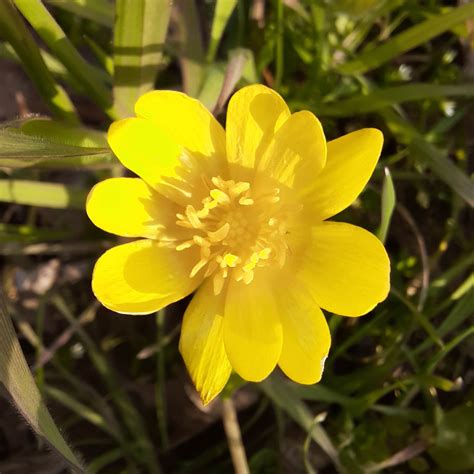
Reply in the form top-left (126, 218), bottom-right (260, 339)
top-left (258, 110), bottom-right (326, 193)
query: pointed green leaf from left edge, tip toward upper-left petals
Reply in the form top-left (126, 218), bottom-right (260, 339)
top-left (0, 124), bottom-right (117, 168)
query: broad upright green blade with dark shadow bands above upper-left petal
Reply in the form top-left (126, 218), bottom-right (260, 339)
top-left (114, 0), bottom-right (172, 117)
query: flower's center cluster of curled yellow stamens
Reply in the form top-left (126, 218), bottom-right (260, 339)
top-left (176, 176), bottom-right (290, 295)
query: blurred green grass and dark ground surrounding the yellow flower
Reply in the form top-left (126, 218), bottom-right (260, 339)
top-left (0, 0), bottom-right (474, 474)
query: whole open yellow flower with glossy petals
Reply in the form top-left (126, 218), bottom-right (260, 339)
top-left (87, 85), bottom-right (390, 403)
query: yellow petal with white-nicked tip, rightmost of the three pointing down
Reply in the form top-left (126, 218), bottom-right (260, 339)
top-left (278, 284), bottom-right (331, 384)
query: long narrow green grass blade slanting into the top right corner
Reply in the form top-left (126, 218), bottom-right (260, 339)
top-left (336, 3), bottom-right (474, 74)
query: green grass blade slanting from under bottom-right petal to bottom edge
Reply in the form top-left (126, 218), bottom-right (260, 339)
top-left (258, 375), bottom-right (345, 473)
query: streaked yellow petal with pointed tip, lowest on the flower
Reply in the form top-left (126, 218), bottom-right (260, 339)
top-left (179, 280), bottom-right (232, 405)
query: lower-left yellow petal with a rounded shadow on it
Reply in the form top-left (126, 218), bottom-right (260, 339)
top-left (92, 240), bottom-right (202, 314)
